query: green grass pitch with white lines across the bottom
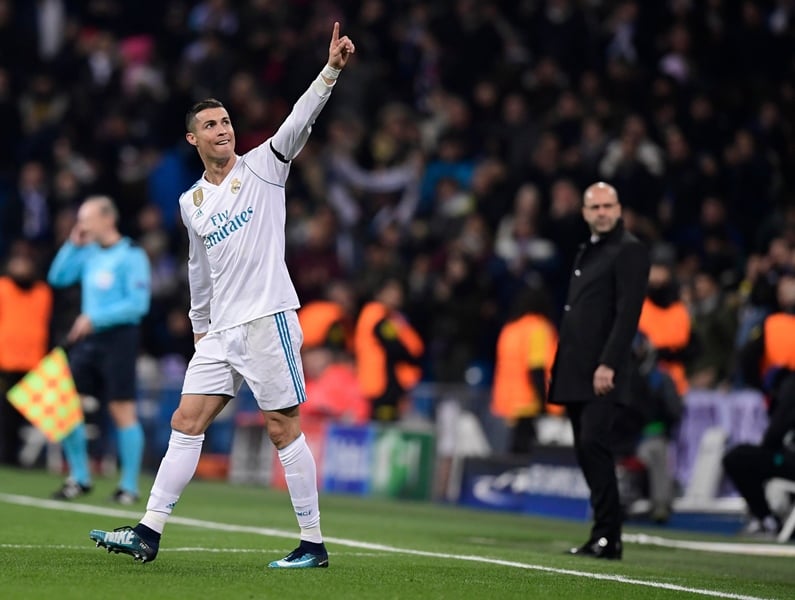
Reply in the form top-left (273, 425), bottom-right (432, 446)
top-left (0, 469), bottom-right (795, 600)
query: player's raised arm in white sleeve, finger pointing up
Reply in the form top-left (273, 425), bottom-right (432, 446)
top-left (270, 22), bottom-right (356, 162)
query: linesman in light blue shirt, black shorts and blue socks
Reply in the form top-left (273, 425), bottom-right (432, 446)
top-left (47, 196), bottom-right (151, 505)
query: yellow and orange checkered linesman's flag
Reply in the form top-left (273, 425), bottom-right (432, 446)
top-left (8, 348), bottom-right (83, 442)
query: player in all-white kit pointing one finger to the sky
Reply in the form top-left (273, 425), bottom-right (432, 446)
top-left (89, 23), bottom-right (355, 568)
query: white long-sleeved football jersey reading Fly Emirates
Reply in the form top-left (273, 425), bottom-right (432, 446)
top-left (179, 77), bottom-right (332, 333)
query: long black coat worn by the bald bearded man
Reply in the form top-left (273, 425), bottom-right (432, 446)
top-left (549, 220), bottom-right (649, 404)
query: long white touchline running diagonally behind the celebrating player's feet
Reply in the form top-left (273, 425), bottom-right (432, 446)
top-left (0, 494), bottom-right (780, 600)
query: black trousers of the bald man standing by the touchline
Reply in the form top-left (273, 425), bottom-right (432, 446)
top-left (566, 399), bottom-right (623, 541)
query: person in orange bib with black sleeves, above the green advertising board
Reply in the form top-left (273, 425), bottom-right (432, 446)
top-left (354, 277), bottom-right (425, 422)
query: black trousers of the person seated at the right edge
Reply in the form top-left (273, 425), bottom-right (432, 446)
top-left (723, 444), bottom-right (795, 519)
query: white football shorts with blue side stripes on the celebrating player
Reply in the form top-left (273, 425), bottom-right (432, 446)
top-left (182, 310), bottom-right (306, 410)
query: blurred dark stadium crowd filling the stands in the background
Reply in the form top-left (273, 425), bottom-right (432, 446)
top-left (0, 0), bottom-right (795, 394)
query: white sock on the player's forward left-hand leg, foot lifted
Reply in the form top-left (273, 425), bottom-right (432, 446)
top-left (141, 430), bottom-right (204, 533)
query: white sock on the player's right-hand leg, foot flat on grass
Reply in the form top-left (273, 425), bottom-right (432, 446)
top-left (278, 433), bottom-right (323, 544)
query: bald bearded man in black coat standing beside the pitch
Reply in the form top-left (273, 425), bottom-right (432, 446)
top-left (549, 182), bottom-right (649, 559)
